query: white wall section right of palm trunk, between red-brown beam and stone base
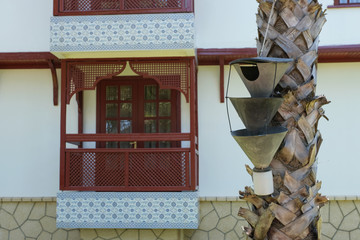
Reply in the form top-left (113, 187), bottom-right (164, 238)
top-left (317, 62), bottom-right (360, 195)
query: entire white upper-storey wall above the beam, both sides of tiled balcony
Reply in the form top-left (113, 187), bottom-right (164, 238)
top-left (0, 0), bottom-right (360, 52)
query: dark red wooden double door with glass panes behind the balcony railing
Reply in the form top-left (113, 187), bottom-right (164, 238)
top-left (98, 77), bottom-right (180, 148)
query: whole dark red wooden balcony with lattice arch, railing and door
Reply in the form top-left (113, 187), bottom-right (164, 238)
top-left (60, 58), bottom-right (198, 192)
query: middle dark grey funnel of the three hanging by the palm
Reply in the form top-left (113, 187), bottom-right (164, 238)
top-left (229, 98), bottom-right (284, 131)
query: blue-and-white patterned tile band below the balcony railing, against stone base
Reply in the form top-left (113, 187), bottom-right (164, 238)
top-left (56, 192), bottom-right (199, 229)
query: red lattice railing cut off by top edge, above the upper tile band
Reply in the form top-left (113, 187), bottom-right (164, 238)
top-left (54, 0), bottom-right (193, 15)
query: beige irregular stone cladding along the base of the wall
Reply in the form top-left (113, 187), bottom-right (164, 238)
top-left (0, 198), bottom-right (360, 240)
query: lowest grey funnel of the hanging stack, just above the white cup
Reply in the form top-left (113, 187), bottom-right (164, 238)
top-left (231, 127), bottom-right (287, 169)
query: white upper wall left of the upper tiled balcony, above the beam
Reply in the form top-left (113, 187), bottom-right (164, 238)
top-left (0, 0), bottom-right (53, 52)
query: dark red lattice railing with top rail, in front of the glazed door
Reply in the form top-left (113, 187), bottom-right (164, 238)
top-left (62, 133), bottom-right (198, 191)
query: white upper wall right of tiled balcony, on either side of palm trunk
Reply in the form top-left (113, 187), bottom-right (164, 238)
top-left (195, 0), bottom-right (360, 48)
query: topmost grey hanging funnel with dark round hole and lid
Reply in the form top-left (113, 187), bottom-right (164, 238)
top-left (230, 57), bottom-right (293, 97)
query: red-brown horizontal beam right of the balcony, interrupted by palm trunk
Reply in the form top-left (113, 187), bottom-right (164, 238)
top-left (197, 44), bottom-right (360, 65)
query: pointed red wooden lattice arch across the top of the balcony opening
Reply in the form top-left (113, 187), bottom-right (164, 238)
top-left (66, 58), bottom-right (190, 104)
